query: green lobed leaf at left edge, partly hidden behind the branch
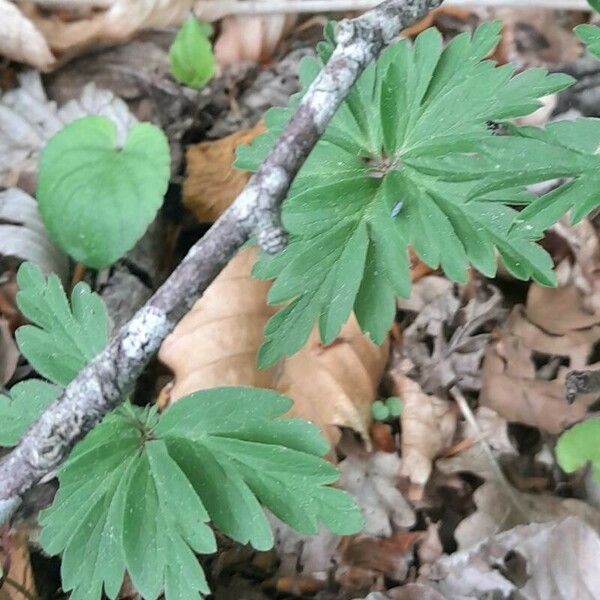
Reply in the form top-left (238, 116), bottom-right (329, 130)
top-left (0, 263), bottom-right (108, 446)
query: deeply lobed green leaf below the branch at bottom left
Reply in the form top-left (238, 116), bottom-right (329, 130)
top-left (41, 388), bottom-right (362, 600)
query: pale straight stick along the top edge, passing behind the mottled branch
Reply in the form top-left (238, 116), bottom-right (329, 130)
top-left (194, 0), bottom-right (591, 21)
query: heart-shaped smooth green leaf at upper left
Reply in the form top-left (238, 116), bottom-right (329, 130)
top-left (37, 117), bottom-right (170, 268)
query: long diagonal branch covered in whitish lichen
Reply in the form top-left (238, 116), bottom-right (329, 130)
top-left (0, 0), bottom-right (442, 522)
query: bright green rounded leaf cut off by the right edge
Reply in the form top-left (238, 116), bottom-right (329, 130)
top-left (556, 419), bottom-right (600, 481)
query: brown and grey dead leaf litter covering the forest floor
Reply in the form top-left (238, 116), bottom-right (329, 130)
top-left (0, 7), bottom-right (600, 600)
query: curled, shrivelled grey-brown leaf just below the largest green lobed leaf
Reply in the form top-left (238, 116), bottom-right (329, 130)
top-left (398, 276), bottom-right (506, 394)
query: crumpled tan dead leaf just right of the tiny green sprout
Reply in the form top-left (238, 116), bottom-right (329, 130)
top-left (393, 374), bottom-right (457, 487)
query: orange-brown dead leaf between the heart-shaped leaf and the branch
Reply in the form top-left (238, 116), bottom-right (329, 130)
top-left (183, 121), bottom-right (265, 223)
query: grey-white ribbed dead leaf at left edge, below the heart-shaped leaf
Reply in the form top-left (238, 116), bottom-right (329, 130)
top-left (0, 188), bottom-right (69, 281)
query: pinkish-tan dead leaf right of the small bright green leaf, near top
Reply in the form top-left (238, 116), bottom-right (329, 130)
top-left (214, 15), bottom-right (297, 66)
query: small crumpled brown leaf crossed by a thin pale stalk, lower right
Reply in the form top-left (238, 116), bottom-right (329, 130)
top-left (435, 406), bottom-right (518, 481)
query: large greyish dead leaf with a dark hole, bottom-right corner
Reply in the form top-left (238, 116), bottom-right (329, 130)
top-left (430, 517), bottom-right (600, 600)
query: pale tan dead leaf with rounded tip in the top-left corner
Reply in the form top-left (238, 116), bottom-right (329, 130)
top-left (0, 0), bottom-right (56, 71)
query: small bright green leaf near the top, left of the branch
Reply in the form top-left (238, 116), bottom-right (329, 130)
top-left (169, 17), bottom-right (215, 89)
